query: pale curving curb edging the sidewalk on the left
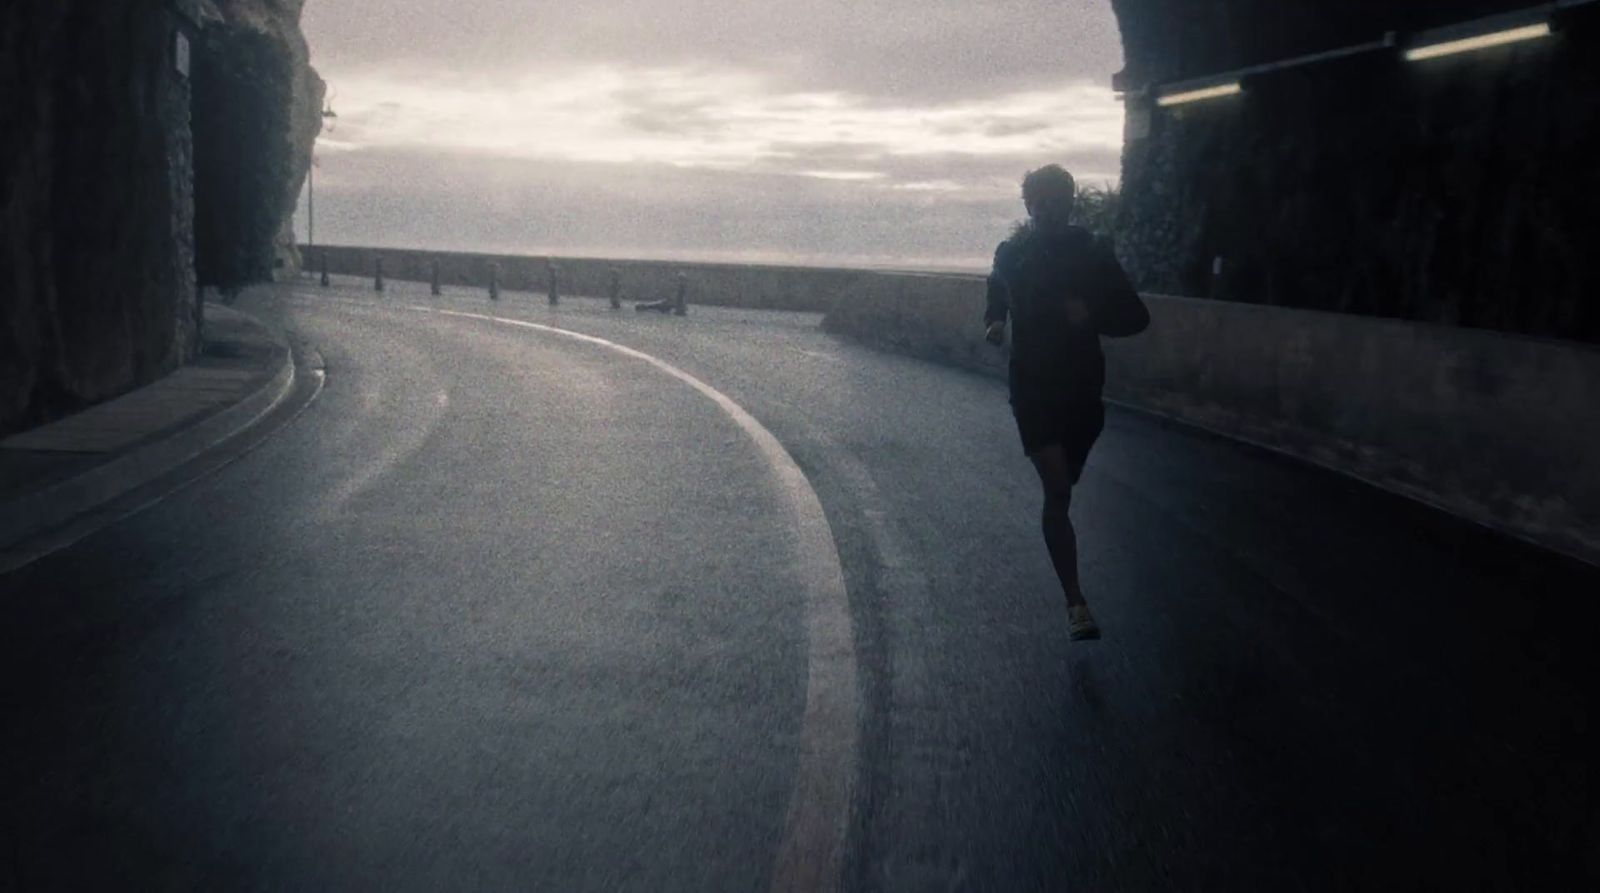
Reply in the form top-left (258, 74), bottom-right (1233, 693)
top-left (0, 310), bottom-right (296, 551)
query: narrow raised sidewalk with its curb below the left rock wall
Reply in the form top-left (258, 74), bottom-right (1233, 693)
top-left (0, 304), bottom-right (294, 571)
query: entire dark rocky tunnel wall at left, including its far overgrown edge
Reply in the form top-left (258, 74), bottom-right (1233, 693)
top-left (0, 0), bottom-right (323, 434)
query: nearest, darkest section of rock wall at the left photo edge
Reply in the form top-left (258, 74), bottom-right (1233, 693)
top-left (0, 0), bottom-right (198, 432)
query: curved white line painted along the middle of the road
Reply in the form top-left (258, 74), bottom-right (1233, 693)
top-left (394, 304), bottom-right (861, 893)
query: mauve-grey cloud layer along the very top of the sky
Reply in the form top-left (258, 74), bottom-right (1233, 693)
top-left (306, 0), bottom-right (1122, 102)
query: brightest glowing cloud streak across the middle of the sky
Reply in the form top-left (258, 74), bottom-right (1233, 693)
top-left (321, 66), bottom-right (1122, 173)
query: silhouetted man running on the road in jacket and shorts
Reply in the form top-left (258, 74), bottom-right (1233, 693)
top-left (984, 165), bottom-right (1150, 640)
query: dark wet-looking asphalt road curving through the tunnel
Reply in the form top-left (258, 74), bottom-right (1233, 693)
top-left (0, 283), bottom-right (1600, 891)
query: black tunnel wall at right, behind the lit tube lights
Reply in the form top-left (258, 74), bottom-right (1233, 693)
top-left (1114, 0), bottom-right (1600, 342)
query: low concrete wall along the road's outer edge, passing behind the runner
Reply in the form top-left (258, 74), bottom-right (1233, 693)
top-left (302, 248), bottom-right (1600, 563)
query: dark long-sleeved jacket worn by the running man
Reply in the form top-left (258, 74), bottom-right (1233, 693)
top-left (984, 226), bottom-right (1150, 403)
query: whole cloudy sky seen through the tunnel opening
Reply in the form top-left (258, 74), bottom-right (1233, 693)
top-left (301, 0), bottom-right (1122, 273)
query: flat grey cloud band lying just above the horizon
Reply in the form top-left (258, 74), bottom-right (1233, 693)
top-left (299, 150), bottom-right (1049, 267)
